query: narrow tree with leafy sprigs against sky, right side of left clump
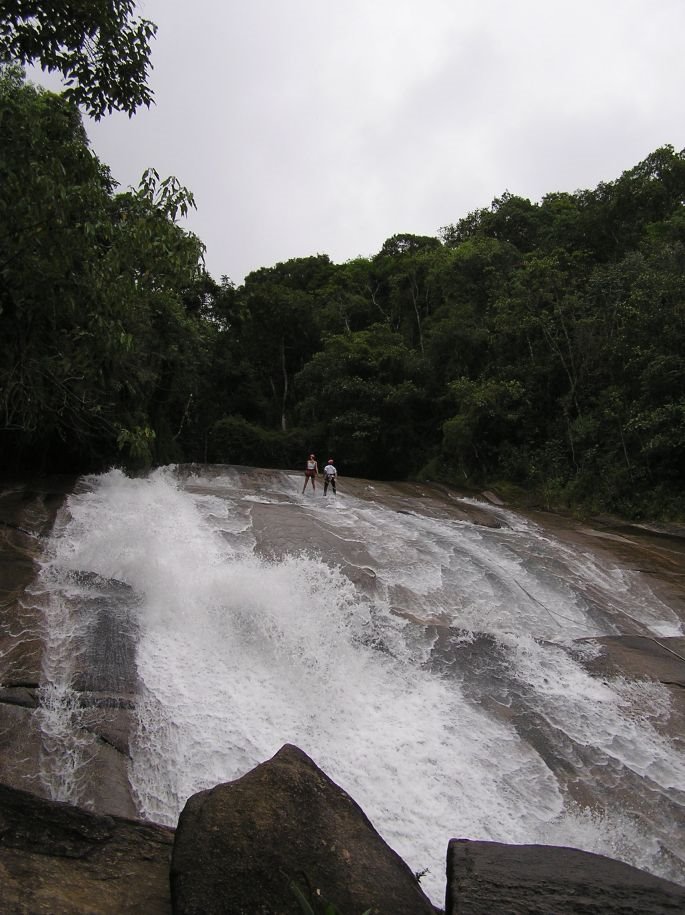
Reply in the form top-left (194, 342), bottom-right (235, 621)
top-left (103, 172), bottom-right (206, 463)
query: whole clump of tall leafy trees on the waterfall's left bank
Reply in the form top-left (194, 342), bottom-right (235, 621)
top-left (0, 69), bottom-right (207, 468)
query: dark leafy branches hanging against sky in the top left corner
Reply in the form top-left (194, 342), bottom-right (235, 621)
top-left (0, 0), bottom-right (157, 120)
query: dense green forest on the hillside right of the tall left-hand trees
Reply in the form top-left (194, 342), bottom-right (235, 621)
top-left (204, 160), bottom-right (685, 518)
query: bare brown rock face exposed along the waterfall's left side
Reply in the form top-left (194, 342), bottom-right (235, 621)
top-left (0, 477), bottom-right (137, 817)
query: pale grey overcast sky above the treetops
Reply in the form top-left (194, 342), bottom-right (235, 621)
top-left (61, 0), bottom-right (685, 284)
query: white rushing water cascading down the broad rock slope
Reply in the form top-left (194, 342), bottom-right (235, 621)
top-left (30, 468), bottom-right (685, 903)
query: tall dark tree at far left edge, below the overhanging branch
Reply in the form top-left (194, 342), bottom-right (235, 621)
top-left (0, 70), bottom-right (112, 466)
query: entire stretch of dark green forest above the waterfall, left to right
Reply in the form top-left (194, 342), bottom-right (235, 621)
top-left (0, 4), bottom-right (685, 520)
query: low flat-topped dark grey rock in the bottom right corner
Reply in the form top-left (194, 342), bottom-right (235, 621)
top-left (445, 839), bottom-right (685, 915)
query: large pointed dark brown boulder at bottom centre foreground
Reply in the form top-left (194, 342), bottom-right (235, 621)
top-left (171, 745), bottom-right (436, 915)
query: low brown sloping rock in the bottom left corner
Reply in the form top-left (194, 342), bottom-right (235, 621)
top-left (0, 785), bottom-right (174, 915)
